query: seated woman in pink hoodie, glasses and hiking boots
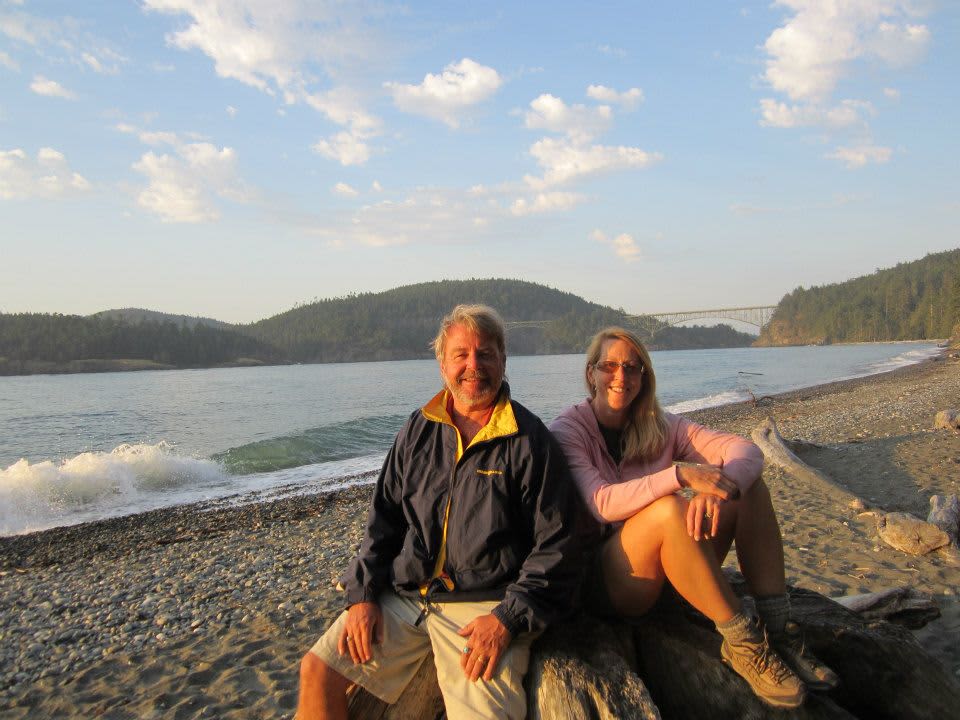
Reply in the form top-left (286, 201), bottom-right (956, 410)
top-left (550, 328), bottom-right (837, 707)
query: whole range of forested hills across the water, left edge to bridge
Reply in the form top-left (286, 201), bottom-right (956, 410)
top-left (0, 280), bottom-right (754, 375)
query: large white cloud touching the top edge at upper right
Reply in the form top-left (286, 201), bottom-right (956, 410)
top-left (764, 0), bottom-right (930, 102)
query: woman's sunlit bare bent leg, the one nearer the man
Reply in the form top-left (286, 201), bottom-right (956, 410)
top-left (601, 495), bottom-right (740, 623)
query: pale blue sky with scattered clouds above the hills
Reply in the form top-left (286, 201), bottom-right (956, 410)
top-left (0, 0), bottom-right (960, 322)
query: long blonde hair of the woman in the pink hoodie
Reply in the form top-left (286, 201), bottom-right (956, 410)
top-left (583, 327), bottom-right (669, 459)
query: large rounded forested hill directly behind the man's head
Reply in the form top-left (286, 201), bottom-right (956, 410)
top-left (242, 280), bottom-right (624, 362)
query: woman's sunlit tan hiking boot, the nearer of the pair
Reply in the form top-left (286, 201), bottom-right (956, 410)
top-left (720, 624), bottom-right (807, 708)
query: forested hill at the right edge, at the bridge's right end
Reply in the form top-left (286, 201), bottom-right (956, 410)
top-left (757, 250), bottom-right (960, 345)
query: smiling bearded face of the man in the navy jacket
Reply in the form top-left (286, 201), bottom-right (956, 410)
top-left (440, 325), bottom-right (506, 412)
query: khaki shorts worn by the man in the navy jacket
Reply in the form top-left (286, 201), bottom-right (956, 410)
top-left (310, 592), bottom-right (536, 720)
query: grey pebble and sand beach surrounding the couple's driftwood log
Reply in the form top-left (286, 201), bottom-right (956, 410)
top-left (0, 357), bottom-right (960, 720)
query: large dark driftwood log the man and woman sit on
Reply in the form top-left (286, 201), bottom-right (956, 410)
top-left (351, 577), bottom-right (960, 720)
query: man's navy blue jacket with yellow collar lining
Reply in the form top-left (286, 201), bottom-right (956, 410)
top-left (342, 383), bottom-right (583, 635)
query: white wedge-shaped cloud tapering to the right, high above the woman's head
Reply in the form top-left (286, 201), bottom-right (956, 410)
top-left (526, 138), bottom-right (662, 188)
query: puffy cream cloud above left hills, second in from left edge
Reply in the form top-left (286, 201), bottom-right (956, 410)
top-left (133, 142), bottom-right (250, 223)
